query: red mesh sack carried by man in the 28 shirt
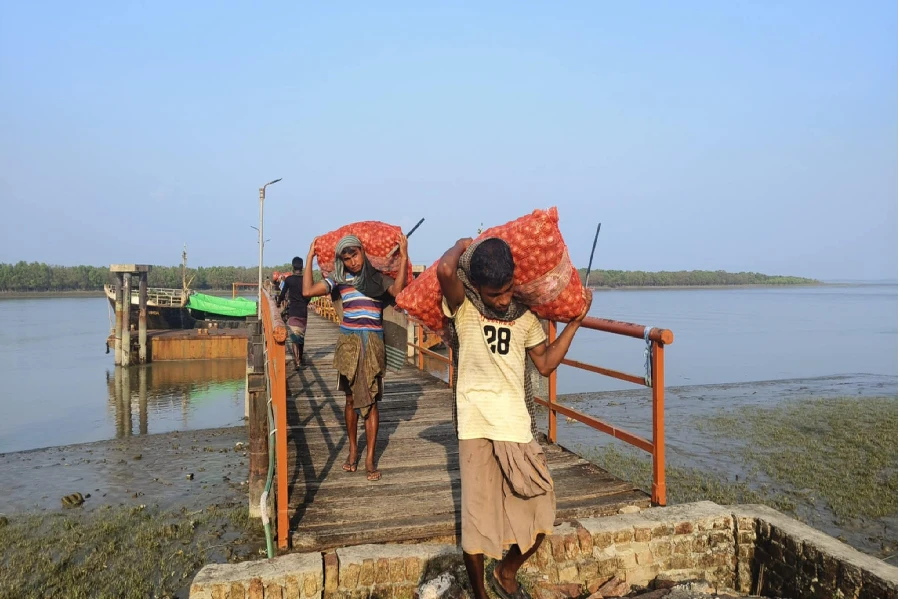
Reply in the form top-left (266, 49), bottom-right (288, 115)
top-left (397, 208), bottom-right (584, 331)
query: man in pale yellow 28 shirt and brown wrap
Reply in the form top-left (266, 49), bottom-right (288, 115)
top-left (437, 238), bottom-right (592, 599)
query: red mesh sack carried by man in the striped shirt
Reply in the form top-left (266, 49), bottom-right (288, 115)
top-left (315, 220), bottom-right (414, 284)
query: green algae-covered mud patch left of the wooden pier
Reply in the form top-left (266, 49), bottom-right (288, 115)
top-left (0, 504), bottom-right (264, 599)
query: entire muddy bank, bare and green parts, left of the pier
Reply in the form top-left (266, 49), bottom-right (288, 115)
top-left (0, 426), bottom-right (265, 598)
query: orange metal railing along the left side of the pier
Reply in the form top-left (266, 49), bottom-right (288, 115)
top-left (259, 292), bottom-right (289, 549)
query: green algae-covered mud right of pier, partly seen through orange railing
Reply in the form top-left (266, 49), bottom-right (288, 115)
top-left (577, 397), bottom-right (898, 559)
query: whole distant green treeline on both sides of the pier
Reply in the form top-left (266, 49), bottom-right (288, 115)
top-left (0, 262), bottom-right (819, 292)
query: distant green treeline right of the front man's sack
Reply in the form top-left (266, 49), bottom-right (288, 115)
top-left (578, 268), bottom-right (821, 287)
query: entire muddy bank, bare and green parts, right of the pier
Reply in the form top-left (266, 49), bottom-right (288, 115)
top-left (541, 374), bottom-right (898, 564)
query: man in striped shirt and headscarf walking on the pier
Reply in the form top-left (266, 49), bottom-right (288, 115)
top-left (303, 234), bottom-right (409, 481)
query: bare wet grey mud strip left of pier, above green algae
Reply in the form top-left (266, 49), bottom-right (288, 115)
top-left (0, 426), bottom-right (249, 515)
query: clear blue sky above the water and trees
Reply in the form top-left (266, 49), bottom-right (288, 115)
top-left (0, 1), bottom-right (897, 279)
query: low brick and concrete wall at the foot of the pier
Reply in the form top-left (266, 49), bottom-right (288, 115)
top-left (191, 502), bottom-right (897, 599)
